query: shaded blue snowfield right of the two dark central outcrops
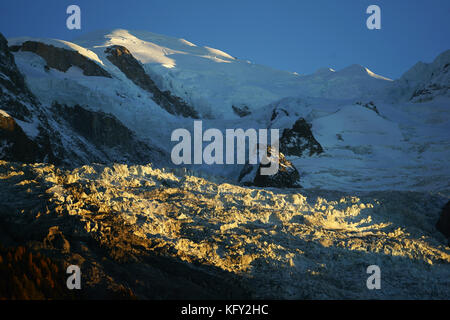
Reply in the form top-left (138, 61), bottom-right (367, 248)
top-left (296, 100), bottom-right (450, 195)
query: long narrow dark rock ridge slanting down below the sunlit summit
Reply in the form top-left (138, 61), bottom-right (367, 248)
top-left (105, 45), bottom-right (199, 119)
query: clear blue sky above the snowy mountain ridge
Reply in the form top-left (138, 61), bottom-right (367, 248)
top-left (0, 0), bottom-right (450, 78)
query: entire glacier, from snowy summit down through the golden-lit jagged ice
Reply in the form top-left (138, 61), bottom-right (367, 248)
top-left (0, 29), bottom-right (450, 299)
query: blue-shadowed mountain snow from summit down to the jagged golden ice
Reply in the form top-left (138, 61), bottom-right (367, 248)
top-left (7, 29), bottom-right (450, 196)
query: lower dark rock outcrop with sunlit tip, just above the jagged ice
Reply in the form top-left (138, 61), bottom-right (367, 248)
top-left (239, 146), bottom-right (301, 188)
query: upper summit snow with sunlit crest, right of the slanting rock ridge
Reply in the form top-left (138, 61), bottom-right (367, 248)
top-left (70, 29), bottom-right (394, 118)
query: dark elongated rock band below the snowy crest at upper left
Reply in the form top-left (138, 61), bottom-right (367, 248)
top-left (11, 41), bottom-right (111, 78)
